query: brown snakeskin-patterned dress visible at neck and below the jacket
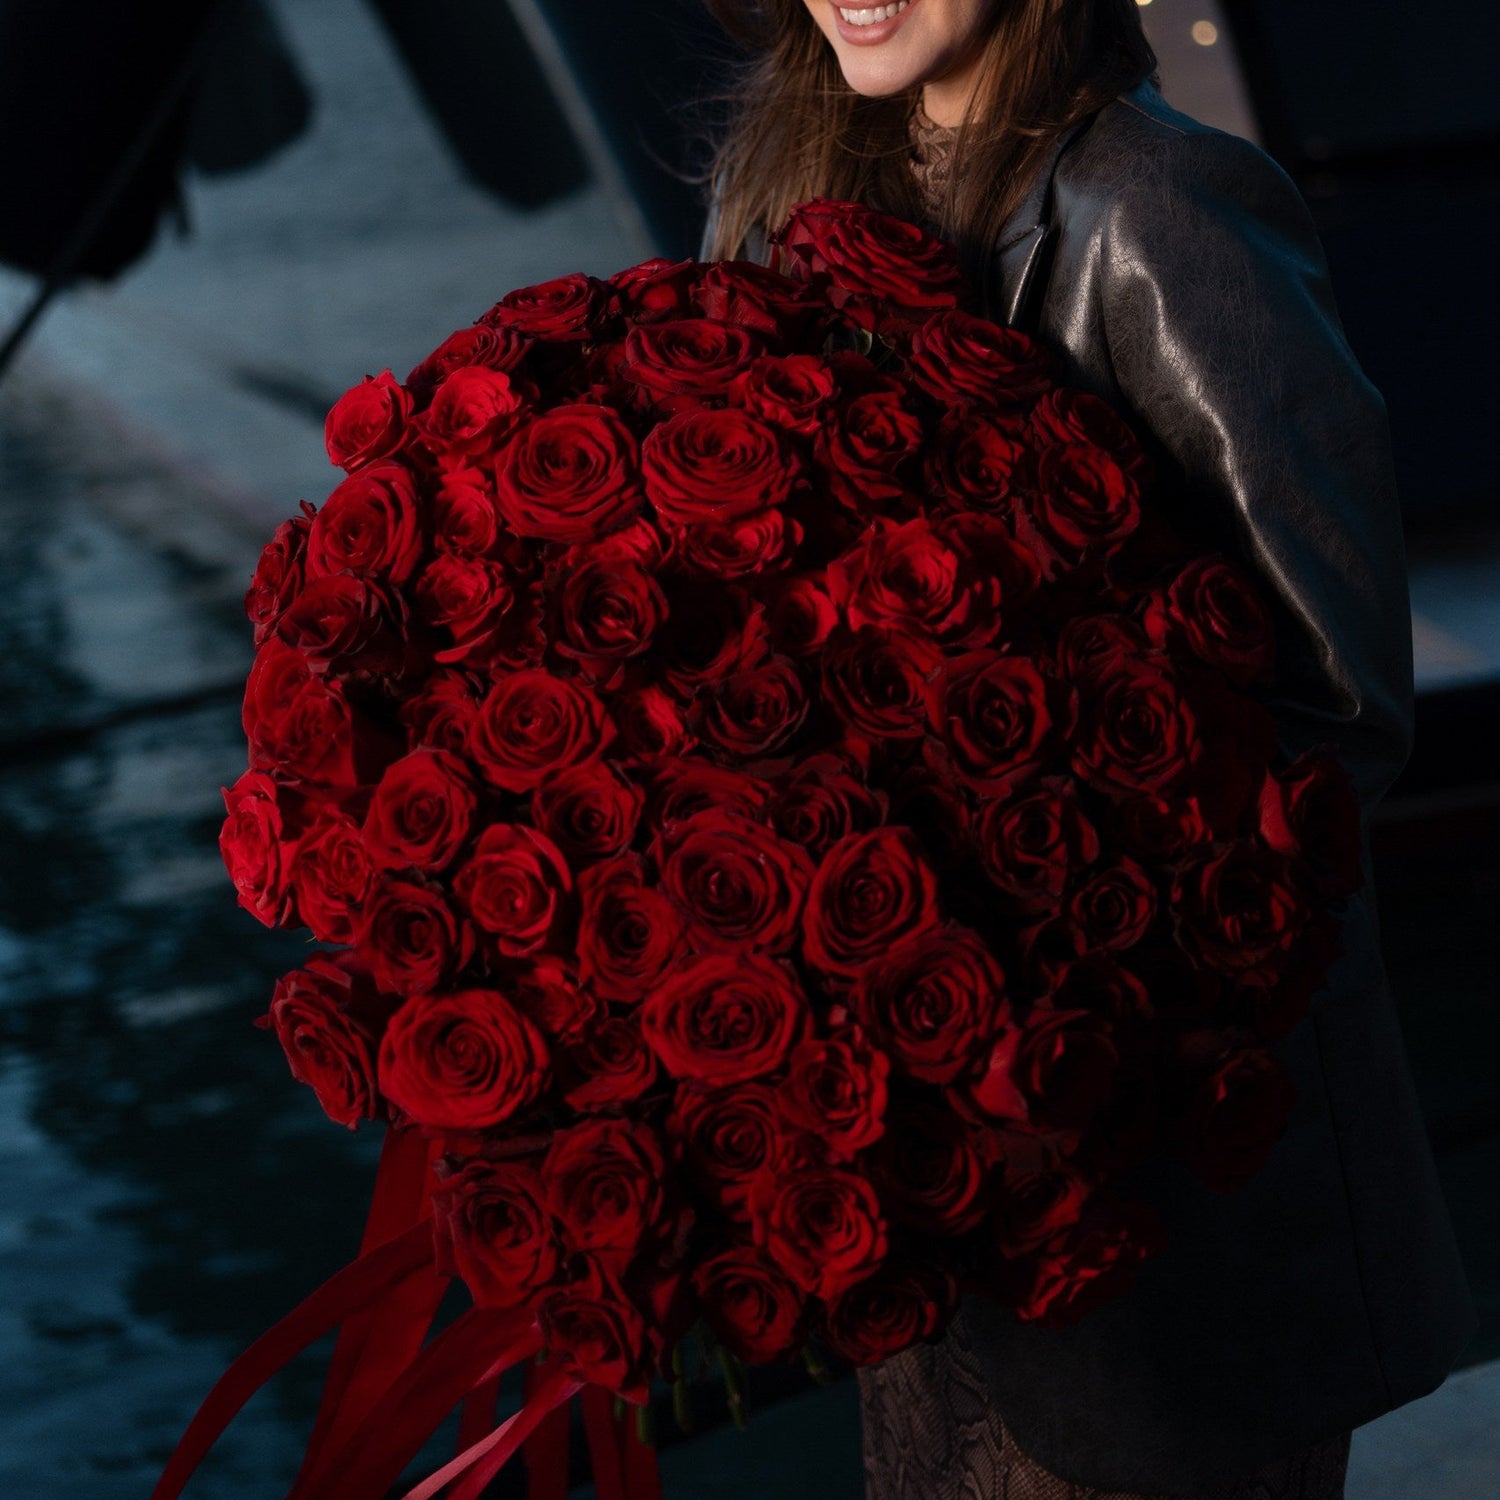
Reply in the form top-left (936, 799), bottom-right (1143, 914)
top-left (858, 105), bottom-right (1350, 1500)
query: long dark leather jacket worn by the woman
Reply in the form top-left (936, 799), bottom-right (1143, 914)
top-left (705, 83), bottom-right (1476, 1494)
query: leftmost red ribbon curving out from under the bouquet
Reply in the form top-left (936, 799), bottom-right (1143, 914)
top-left (152, 1223), bottom-right (432, 1500)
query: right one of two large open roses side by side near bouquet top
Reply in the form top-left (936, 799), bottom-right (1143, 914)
top-left (641, 408), bottom-right (800, 527)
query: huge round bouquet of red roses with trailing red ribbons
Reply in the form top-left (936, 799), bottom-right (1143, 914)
top-left (161, 201), bottom-right (1361, 1500)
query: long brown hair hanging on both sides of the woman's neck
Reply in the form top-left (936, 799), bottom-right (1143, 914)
top-left (707, 0), bottom-right (1160, 285)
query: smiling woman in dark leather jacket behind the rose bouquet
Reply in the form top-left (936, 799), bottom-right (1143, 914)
top-left (704, 0), bottom-right (1475, 1500)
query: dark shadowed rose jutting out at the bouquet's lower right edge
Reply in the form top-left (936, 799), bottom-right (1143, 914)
top-left (1172, 1032), bottom-right (1299, 1193)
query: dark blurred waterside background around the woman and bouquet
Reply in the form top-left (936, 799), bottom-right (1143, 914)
top-left (0, 0), bottom-right (1500, 1500)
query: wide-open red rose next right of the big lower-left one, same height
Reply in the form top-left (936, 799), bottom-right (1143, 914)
top-left (641, 953), bottom-right (810, 1086)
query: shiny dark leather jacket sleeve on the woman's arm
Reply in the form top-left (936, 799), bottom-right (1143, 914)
top-left (1100, 132), bottom-right (1413, 813)
